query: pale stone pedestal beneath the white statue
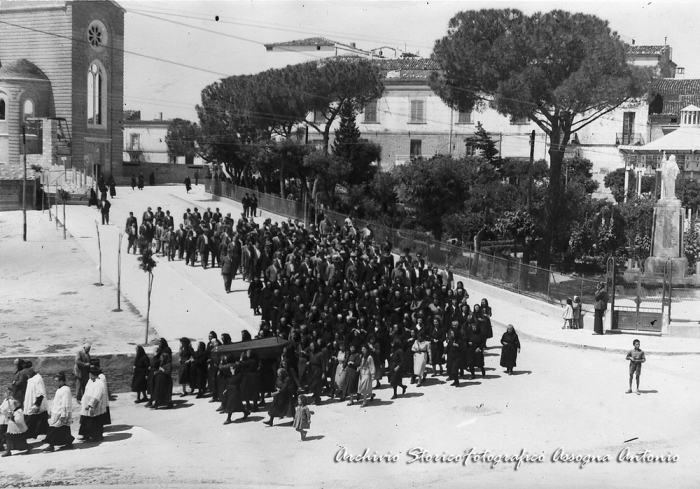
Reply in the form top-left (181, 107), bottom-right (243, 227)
top-left (644, 198), bottom-right (688, 279)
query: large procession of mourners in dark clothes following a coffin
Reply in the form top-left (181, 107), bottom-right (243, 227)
top-left (121, 205), bottom-right (520, 434)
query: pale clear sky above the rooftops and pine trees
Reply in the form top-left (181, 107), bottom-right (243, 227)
top-left (118, 0), bottom-right (700, 121)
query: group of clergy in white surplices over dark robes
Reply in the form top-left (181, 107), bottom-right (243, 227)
top-left (0, 345), bottom-right (112, 457)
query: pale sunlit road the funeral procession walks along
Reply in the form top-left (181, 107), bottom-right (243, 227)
top-left (5, 187), bottom-right (700, 488)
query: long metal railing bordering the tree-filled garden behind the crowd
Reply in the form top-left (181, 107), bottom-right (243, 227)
top-left (206, 179), bottom-right (599, 312)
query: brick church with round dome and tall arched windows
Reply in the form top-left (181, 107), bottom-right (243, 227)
top-left (0, 0), bottom-right (125, 176)
